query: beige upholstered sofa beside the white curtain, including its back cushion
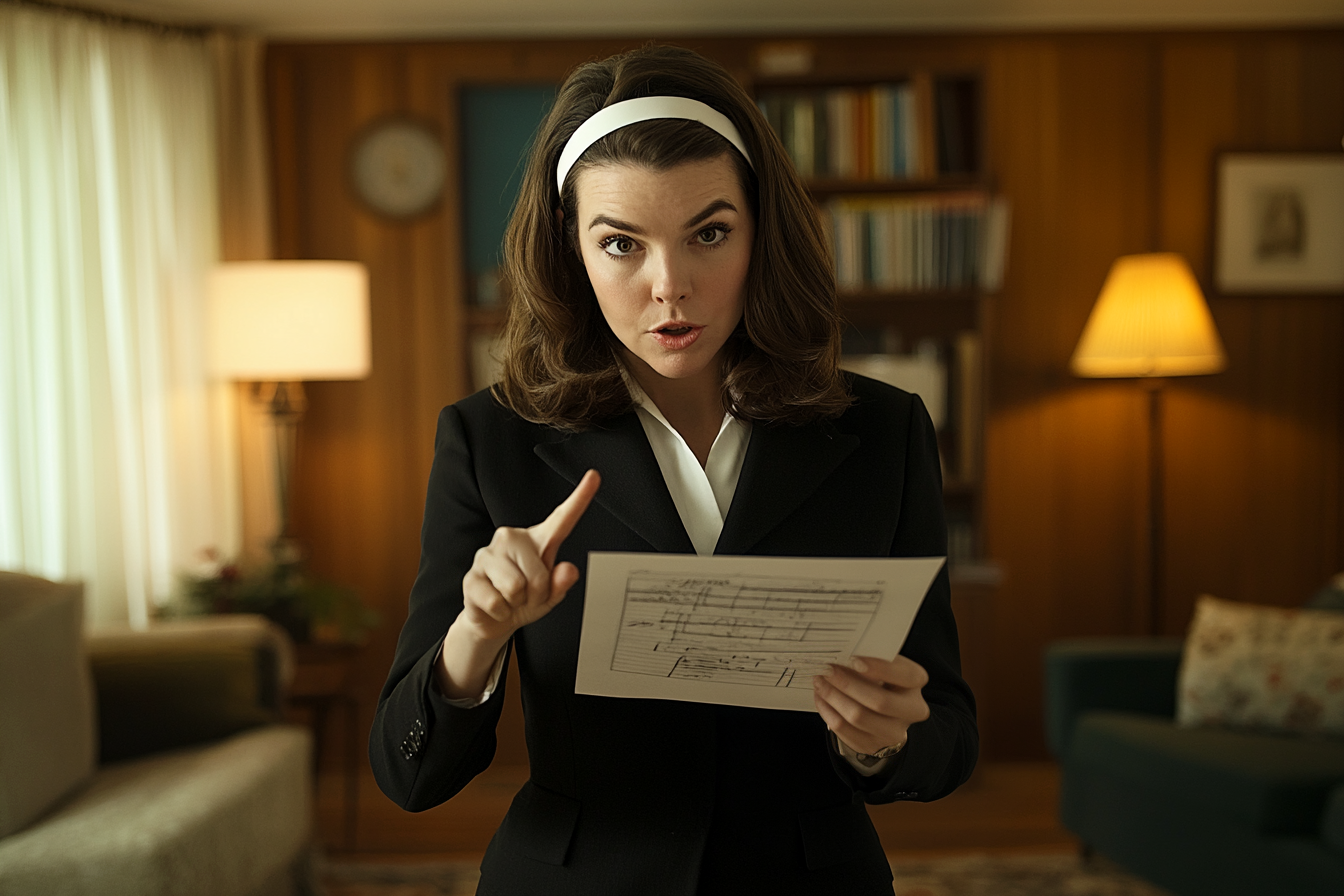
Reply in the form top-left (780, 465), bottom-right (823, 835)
top-left (0, 572), bottom-right (312, 896)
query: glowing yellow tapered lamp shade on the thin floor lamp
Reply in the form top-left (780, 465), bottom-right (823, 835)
top-left (1068, 253), bottom-right (1227, 376)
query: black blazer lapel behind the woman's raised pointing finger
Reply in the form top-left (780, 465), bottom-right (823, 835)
top-left (532, 412), bottom-right (695, 553)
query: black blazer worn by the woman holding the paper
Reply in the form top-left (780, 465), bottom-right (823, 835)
top-left (370, 377), bottom-right (978, 895)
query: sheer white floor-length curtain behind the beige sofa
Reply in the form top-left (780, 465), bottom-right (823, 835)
top-left (0, 4), bottom-right (238, 626)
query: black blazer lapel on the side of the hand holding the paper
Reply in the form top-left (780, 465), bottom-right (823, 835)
top-left (714, 423), bottom-right (859, 553)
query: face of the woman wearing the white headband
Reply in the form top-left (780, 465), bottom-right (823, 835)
top-left (575, 154), bottom-right (754, 383)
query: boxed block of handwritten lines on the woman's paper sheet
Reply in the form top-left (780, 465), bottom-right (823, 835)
top-left (612, 570), bottom-right (883, 690)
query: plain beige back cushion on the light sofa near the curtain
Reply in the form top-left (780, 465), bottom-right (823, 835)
top-left (0, 572), bottom-right (97, 838)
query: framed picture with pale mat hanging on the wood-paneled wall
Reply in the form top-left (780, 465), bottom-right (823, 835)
top-left (1214, 152), bottom-right (1344, 294)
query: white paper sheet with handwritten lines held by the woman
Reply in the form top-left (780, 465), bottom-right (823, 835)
top-left (574, 551), bottom-right (945, 712)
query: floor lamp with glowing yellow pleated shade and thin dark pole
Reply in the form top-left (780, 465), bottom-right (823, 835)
top-left (1070, 253), bottom-right (1227, 634)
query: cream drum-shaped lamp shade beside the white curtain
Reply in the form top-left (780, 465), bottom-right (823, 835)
top-left (207, 261), bottom-right (370, 382)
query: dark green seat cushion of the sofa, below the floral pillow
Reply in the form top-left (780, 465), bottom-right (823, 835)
top-left (1064, 711), bottom-right (1344, 840)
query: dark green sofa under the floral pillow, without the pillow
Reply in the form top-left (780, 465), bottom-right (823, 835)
top-left (1046, 591), bottom-right (1344, 896)
